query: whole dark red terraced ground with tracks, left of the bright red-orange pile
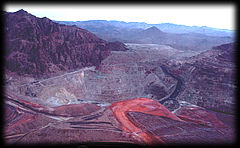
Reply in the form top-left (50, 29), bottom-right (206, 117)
top-left (4, 95), bottom-right (136, 144)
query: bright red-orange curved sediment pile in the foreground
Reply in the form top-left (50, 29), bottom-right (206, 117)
top-left (110, 98), bottom-right (182, 144)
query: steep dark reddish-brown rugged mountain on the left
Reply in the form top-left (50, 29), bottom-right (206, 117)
top-left (3, 10), bottom-right (127, 77)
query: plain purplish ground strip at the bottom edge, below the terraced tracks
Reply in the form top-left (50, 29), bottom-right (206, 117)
top-left (18, 126), bottom-right (137, 144)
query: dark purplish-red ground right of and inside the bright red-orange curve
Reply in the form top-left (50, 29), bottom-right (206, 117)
top-left (127, 112), bottom-right (235, 145)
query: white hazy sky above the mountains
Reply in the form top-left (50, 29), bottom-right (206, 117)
top-left (4, 4), bottom-right (236, 29)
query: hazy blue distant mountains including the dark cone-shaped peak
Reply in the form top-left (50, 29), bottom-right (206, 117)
top-left (56, 20), bottom-right (234, 51)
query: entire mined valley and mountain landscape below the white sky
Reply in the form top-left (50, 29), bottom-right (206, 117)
top-left (3, 10), bottom-right (236, 145)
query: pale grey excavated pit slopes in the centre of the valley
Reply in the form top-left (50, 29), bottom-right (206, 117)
top-left (5, 45), bottom-right (186, 111)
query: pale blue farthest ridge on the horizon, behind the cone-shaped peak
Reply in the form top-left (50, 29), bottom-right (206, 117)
top-left (56, 20), bottom-right (234, 37)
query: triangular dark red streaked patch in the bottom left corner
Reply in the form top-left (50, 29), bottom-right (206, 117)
top-left (4, 104), bottom-right (56, 143)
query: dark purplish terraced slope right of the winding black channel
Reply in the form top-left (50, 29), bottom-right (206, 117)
top-left (171, 43), bottom-right (236, 113)
